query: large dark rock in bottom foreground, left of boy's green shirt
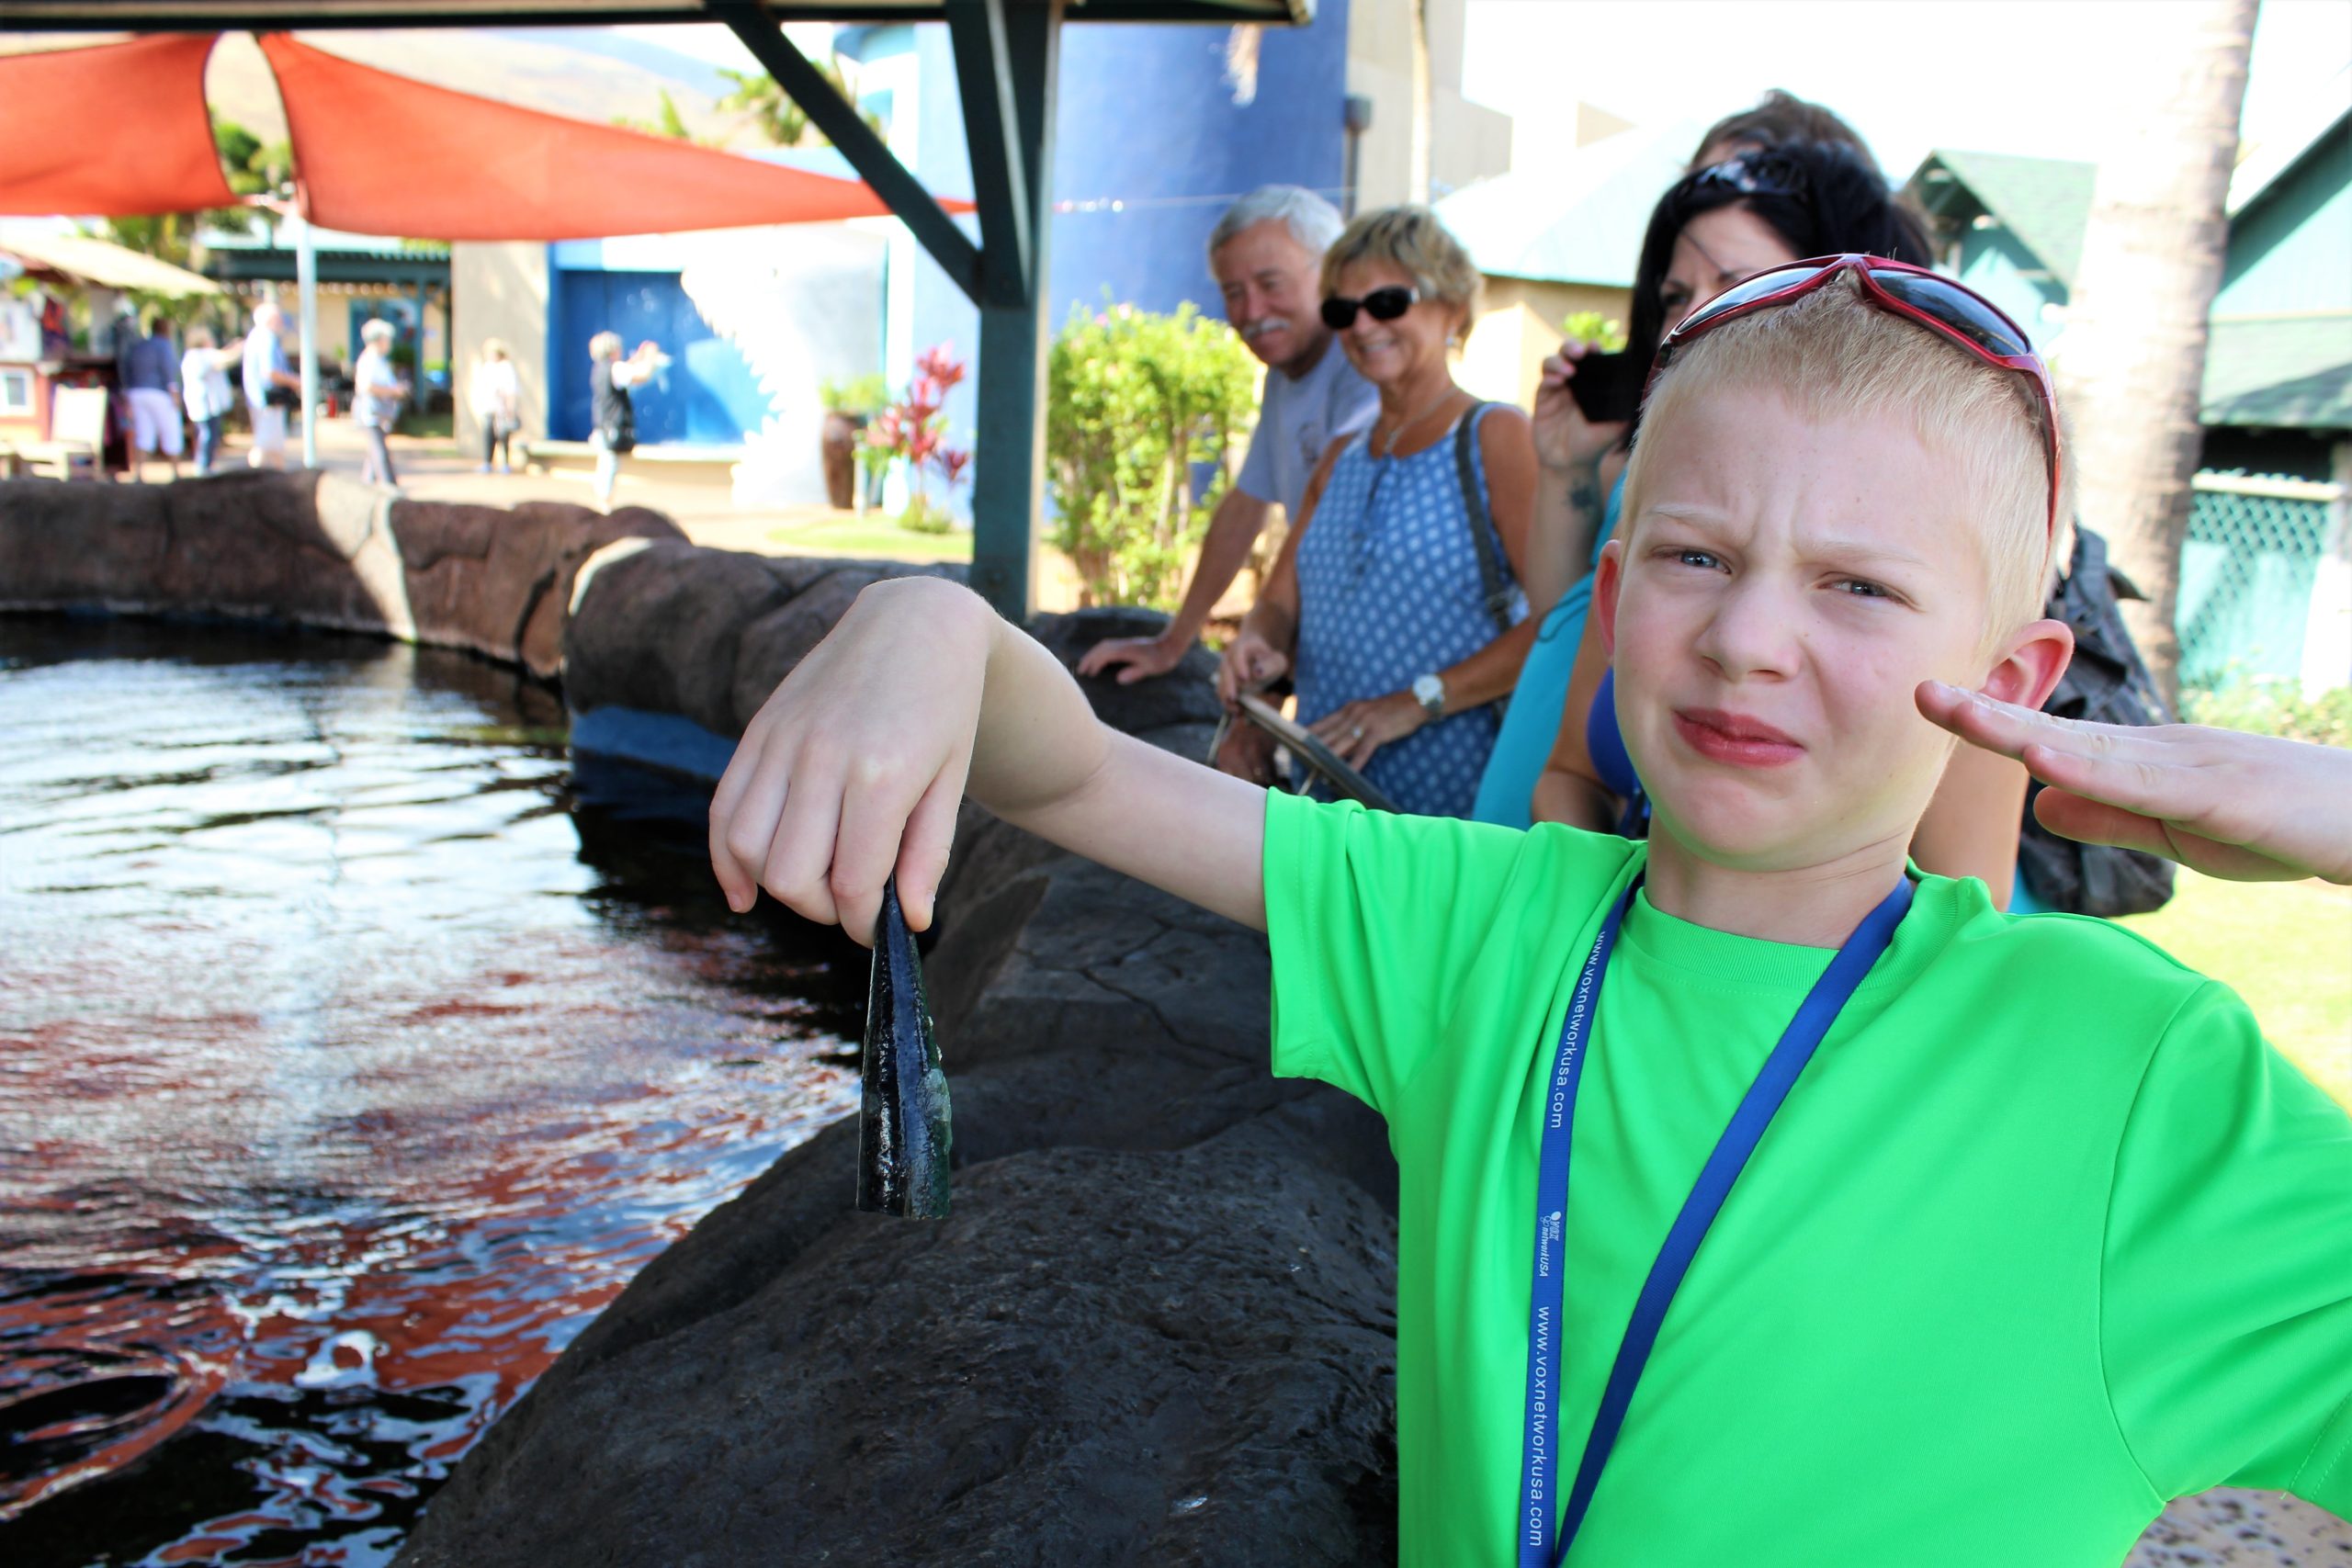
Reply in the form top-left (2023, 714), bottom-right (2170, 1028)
top-left (400, 1128), bottom-right (1395, 1568)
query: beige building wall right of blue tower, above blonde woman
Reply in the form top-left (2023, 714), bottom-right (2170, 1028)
top-left (1348, 0), bottom-right (1510, 211)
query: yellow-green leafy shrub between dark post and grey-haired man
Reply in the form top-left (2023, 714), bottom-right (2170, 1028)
top-left (1045, 303), bottom-right (1256, 609)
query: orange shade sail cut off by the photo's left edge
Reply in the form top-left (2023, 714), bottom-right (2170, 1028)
top-left (0, 33), bottom-right (238, 219)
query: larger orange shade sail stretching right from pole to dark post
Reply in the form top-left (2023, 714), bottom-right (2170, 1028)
top-left (261, 33), bottom-right (971, 240)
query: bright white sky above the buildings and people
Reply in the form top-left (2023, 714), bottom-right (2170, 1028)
top-left (621, 0), bottom-right (2352, 179)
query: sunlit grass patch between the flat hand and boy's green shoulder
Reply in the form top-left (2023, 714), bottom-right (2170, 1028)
top-left (2117, 870), bottom-right (2352, 1107)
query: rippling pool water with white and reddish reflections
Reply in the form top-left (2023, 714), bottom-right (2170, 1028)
top-left (0, 616), bottom-right (864, 1568)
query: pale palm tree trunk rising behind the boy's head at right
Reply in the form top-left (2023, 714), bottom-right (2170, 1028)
top-left (2058, 0), bottom-right (2256, 701)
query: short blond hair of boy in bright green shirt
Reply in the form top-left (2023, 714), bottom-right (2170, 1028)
top-left (1621, 277), bottom-right (2075, 644)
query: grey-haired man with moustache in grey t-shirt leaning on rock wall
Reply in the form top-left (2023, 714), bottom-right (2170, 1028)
top-left (1077, 186), bottom-right (1381, 684)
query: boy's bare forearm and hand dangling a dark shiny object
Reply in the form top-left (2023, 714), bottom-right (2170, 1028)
top-left (710, 579), bottom-right (1265, 942)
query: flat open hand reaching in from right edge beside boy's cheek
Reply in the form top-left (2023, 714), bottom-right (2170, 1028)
top-left (1917, 682), bottom-right (2352, 882)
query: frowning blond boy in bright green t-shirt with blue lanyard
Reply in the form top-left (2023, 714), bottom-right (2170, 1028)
top-left (710, 259), bottom-right (2352, 1568)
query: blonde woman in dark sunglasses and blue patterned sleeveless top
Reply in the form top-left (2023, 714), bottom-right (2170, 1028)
top-left (1218, 207), bottom-right (1536, 816)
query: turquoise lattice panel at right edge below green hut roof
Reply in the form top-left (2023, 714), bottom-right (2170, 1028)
top-left (2173, 472), bottom-right (2338, 691)
